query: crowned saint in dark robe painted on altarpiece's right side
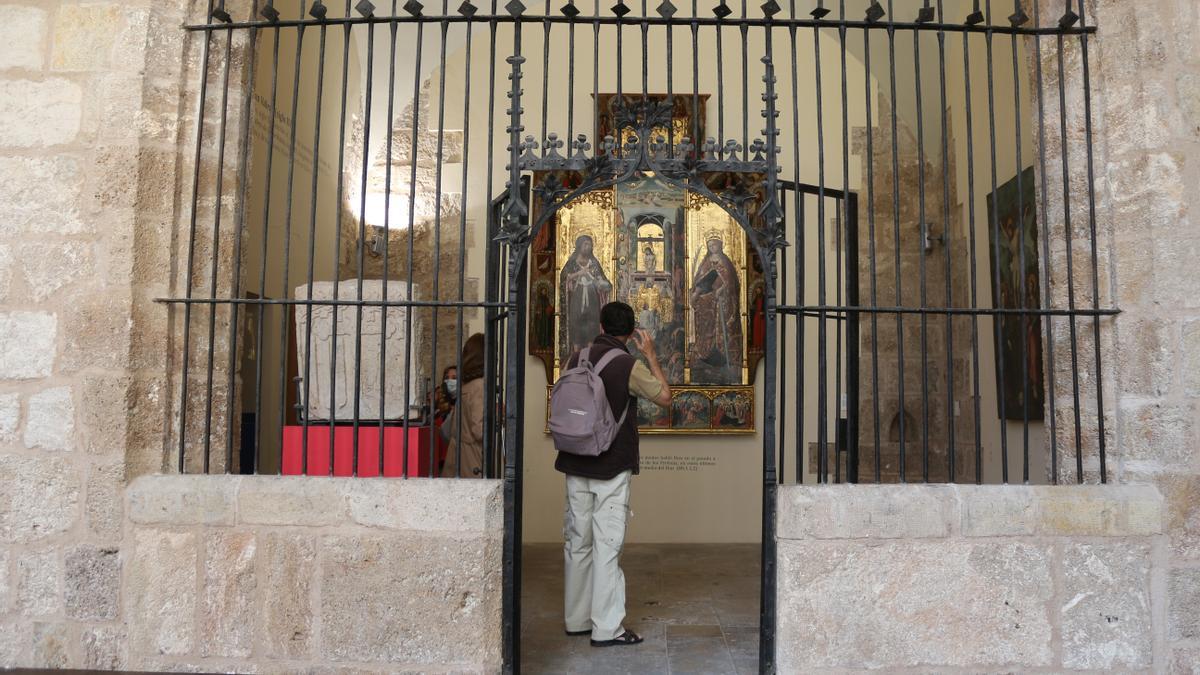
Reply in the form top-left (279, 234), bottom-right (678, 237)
top-left (690, 231), bottom-right (743, 384)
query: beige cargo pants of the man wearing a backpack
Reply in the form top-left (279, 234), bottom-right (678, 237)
top-left (563, 471), bottom-right (630, 640)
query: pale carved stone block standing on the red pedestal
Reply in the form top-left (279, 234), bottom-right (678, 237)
top-left (295, 279), bottom-right (424, 422)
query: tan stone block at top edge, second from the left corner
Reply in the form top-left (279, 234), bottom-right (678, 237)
top-left (50, 2), bottom-right (122, 71)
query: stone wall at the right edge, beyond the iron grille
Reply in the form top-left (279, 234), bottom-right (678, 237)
top-left (1028, 0), bottom-right (1200, 671)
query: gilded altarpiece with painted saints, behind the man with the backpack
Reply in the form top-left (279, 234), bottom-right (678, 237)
top-left (529, 95), bottom-right (766, 434)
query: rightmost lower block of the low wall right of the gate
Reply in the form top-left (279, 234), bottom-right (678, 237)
top-left (1061, 543), bottom-right (1154, 670)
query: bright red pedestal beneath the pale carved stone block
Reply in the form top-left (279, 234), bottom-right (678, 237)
top-left (283, 424), bottom-right (440, 478)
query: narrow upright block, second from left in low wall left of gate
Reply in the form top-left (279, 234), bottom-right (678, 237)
top-left (199, 531), bottom-right (256, 657)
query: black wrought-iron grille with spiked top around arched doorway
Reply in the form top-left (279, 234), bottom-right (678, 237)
top-left (163, 0), bottom-right (1116, 673)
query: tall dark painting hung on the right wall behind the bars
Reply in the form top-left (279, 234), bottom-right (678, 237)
top-left (988, 167), bottom-right (1045, 420)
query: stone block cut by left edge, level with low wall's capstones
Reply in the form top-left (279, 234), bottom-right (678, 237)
top-left (0, 455), bottom-right (79, 543)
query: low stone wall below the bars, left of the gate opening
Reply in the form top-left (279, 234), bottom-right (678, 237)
top-left (119, 476), bottom-right (504, 673)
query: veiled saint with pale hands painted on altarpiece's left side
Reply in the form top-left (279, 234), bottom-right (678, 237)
top-left (558, 234), bottom-right (612, 358)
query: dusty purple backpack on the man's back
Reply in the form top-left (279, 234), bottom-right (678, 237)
top-left (550, 347), bottom-right (629, 458)
